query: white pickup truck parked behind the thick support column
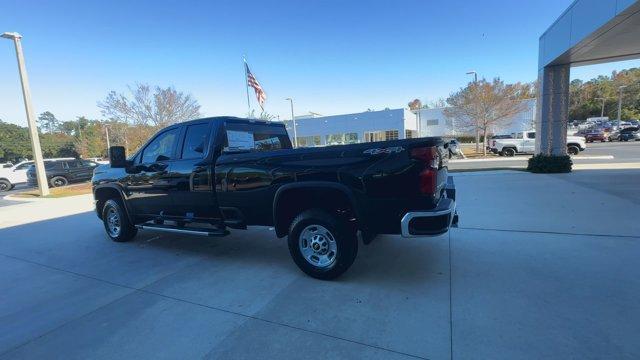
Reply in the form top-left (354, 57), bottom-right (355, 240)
top-left (490, 131), bottom-right (587, 156)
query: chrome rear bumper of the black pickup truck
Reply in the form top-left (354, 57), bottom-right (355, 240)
top-left (400, 177), bottom-right (458, 237)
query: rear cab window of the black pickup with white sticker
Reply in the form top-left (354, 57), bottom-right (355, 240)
top-left (224, 122), bottom-right (291, 151)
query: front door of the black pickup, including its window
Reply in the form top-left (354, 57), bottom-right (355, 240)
top-left (126, 126), bottom-right (180, 216)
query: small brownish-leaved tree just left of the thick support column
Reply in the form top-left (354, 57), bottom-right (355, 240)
top-left (444, 78), bottom-right (526, 155)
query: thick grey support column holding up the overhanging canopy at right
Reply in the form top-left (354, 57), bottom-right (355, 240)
top-left (536, 65), bottom-right (570, 156)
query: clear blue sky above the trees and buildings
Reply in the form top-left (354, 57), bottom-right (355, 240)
top-left (0, 0), bottom-right (638, 124)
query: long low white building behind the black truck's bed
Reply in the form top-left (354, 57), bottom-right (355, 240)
top-left (285, 99), bottom-right (536, 147)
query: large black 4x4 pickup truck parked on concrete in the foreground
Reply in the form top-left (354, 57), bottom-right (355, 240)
top-left (92, 117), bottom-right (458, 279)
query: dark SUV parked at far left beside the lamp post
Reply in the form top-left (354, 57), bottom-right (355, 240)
top-left (27, 159), bottom-right (98, 187)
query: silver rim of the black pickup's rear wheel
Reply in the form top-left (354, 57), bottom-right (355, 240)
top-left (298, 225), bottom-right (338, 269)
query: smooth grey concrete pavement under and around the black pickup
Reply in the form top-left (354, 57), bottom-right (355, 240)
top-left (0, 170), bottom-right (640, 359)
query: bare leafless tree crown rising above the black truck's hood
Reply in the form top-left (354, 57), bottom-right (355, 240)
top-left (98, 84), bottom-right (200, 126)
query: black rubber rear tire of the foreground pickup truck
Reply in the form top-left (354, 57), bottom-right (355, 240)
top-left (288, 209), bottom-right (358, 280)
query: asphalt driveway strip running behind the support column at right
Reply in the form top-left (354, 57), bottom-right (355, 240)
top-left (449, 141), bottom-right (640, 171)
